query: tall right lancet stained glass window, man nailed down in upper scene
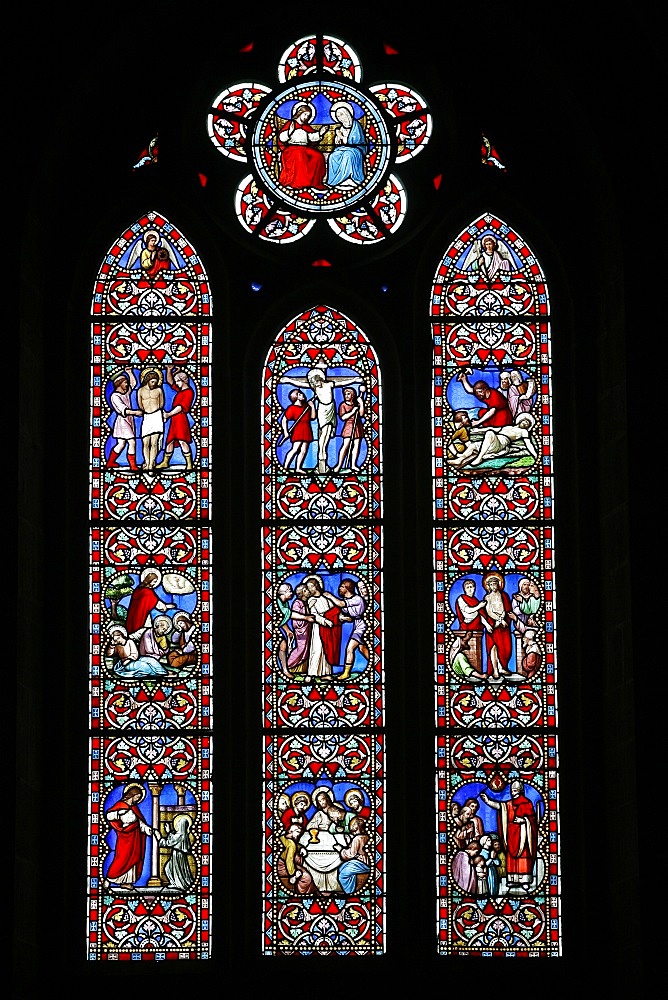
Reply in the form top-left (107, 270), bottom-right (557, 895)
top-left (431, 214), bottom-right (561, 957)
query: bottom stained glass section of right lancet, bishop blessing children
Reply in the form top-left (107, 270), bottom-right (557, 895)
top-left (437, 730), bottom-right (561, 958)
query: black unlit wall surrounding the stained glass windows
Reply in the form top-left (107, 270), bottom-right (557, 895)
top-left (14, 2), bottom-right (652, 997)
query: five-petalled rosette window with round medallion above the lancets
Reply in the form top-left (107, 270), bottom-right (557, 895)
top-left (208, 35), bottom-right (432, 245)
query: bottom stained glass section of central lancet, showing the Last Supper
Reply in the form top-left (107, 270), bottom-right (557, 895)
top-left (264, 731), bottom-right (385, 955)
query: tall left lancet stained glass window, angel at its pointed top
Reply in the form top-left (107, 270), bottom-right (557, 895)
top-left (88, 212), bottom-right (212, 960)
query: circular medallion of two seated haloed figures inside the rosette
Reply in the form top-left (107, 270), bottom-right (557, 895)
top-left (251, 80), bottom-right (393, 215)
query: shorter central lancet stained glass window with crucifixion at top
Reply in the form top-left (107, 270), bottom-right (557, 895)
top-left (262, 305), bottom-right (386, 955)
